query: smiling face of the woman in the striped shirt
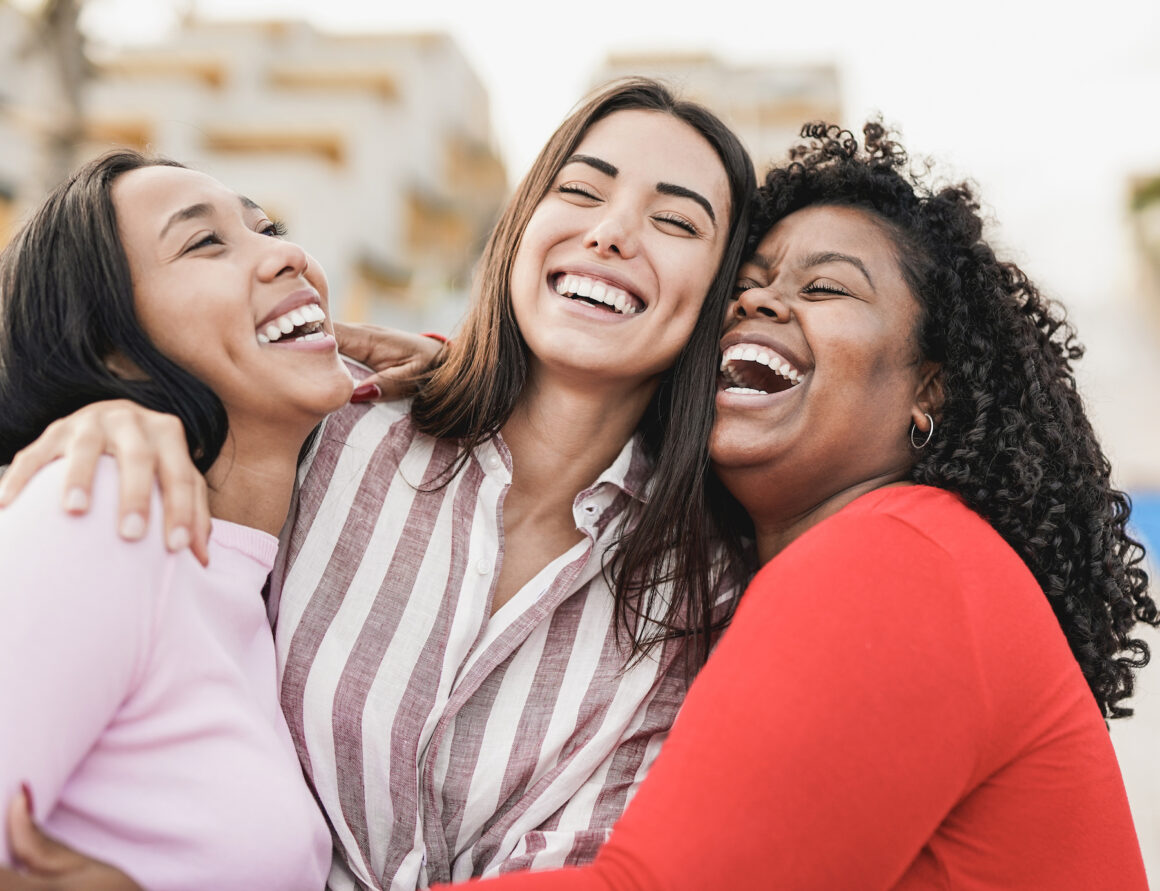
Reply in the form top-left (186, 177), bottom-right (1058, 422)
top-left (512, 110), bottom-right (730, 387)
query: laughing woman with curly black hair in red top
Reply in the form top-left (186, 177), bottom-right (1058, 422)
top-left (422, 124), bottom-right (1158, 891)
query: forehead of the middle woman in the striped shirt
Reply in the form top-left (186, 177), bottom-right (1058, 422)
top-left (574, 109), bottom-right (728, 207)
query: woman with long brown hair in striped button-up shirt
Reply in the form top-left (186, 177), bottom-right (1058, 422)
top-left (0, 80), bottom-right (753, 889)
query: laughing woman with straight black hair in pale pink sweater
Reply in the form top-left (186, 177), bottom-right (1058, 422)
top-left (0, 152), bottom-right (351, 891)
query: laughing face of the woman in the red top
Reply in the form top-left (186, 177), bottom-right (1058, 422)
top-left (711, 207), bottom-right (937, 552)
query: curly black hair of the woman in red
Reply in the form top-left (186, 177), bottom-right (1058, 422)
top-left (748, 121), bottom-right (1160, 718)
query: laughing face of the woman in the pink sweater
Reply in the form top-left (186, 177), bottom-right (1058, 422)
top-left (111, 166), bottom-right (351, 437)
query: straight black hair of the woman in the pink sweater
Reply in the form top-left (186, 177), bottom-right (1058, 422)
top-left (0, 151), bottom-right (227, 472)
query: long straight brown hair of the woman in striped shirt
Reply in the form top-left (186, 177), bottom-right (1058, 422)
top-left (412, 78), bottom-right (755, 661)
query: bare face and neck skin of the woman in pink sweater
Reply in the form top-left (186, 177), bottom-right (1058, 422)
top-left (113, 167), bottom-right (351, 535)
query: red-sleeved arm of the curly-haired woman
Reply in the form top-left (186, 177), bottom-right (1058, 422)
top-left (452, 517), bottom-right (989, 891)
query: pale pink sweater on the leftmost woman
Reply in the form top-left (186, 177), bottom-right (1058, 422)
top-left (0, 458), bottom-right (331, 891)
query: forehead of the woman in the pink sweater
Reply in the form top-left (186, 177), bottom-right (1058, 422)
top-left (111, 166), bottom-right (241, 232)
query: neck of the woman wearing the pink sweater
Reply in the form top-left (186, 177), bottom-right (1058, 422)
top-left (205, 425), bottom-right (305, 535)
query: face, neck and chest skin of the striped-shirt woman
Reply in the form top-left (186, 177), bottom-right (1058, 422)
top-left (492, 110), bottom-right (730, 613)
